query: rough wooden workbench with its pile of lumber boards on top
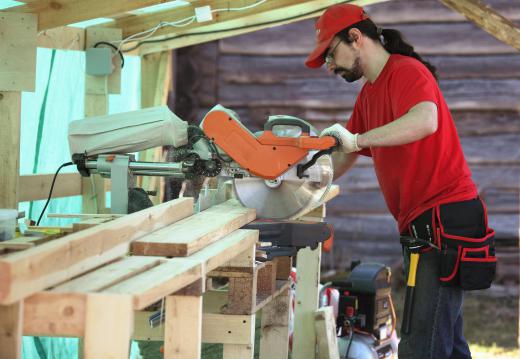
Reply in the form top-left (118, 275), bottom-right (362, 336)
top-left (0, 194), bottom-right (337, 359)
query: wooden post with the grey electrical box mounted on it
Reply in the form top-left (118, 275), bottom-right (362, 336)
top-left (82, 27), bottom-right (122, 213)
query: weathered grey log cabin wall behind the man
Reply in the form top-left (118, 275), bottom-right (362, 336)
top-left (176, 0), bottom-right (520, 282)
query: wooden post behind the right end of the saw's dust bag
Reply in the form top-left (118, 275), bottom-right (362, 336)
top-left (138, 51), bottom-right (172, 204)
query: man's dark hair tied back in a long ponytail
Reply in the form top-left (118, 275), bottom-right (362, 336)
top-left (337, 19), bottom-right (439, 81)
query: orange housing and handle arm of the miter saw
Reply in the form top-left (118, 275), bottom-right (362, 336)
top-left (202, 110), bottom-right (336, 179)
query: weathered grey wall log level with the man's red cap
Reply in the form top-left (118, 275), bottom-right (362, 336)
top-left (220, 20), bottom-right (516, 55)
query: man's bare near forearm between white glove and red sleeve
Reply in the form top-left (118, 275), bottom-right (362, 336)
top-left (357, 102), bottom-right (437, 148)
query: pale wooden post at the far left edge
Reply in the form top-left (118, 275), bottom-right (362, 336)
top-left (0, 12), bottom-right (38, 359)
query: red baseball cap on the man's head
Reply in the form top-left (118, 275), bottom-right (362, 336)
top-left (305, 4), bottom-right (368, 68)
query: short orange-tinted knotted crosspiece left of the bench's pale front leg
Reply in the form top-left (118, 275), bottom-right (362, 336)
top-left (23, 292), bottom-right (87, 337)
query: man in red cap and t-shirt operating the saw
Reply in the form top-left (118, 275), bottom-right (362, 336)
top-left (305, 4), bottom-right (496, 359)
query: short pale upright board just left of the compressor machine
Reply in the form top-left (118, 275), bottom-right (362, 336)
top-left (314, 307), bottom-right (339, 359)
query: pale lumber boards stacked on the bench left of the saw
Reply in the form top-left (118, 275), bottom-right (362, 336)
top-left (0, 198), bottom-right (283, 358)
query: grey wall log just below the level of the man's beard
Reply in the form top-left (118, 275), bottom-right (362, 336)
top-left (217, 77), bottom-right (520, 111)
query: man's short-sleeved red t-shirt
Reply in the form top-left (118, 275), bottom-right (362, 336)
top-left (346, 54), bottom-right (477, 233)
